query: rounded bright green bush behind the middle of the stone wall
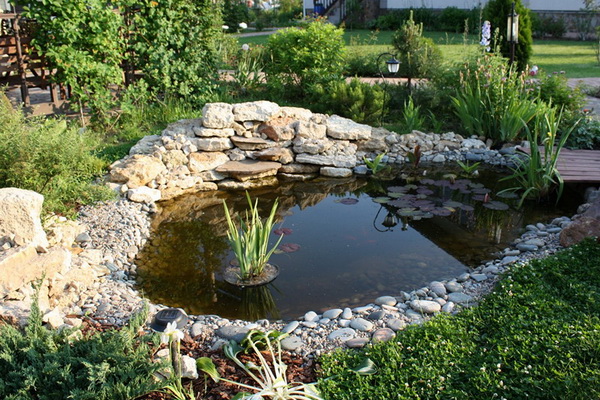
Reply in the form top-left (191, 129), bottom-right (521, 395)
top-left (265, 19), bottom-right (345, 93)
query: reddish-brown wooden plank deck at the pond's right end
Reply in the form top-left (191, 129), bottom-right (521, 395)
top-left (519, 148), bottom-right (600, 183)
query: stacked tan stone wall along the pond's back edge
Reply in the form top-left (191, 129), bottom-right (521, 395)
top-left (105, 101), bottom-right (494, 203)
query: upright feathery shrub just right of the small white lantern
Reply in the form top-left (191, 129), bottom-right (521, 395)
top-left (392, 13), bottom-right (441, 87)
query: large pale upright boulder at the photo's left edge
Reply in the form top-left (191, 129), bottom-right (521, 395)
top-left (0, 188), bottom-right (48, 247)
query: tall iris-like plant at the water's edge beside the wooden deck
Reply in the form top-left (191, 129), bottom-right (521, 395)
top-left (500, 107), bottom-right (577, 207)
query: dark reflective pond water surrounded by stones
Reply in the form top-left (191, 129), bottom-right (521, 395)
top-left (137, 169), bottom-right (580, 320)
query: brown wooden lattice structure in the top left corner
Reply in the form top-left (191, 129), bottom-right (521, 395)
top-left (0, 13), bottom-right (59, 106)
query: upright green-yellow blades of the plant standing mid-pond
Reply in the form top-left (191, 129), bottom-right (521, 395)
top-left (223, 192), bottom-right (283, 280)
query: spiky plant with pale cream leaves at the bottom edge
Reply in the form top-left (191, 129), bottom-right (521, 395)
top-left (196, 331), bottom-right (321, 400)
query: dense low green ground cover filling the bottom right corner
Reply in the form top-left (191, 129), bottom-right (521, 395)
top-left (319, 239), bottom-right (600, 400)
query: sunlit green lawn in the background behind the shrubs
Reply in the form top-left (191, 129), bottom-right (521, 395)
top-left (240, 30), bottom-right (600, 78)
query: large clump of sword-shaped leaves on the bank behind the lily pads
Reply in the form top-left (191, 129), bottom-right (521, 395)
top-left (452, 55), bottom-right (538, 144)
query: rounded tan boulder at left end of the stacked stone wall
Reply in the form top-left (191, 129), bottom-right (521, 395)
top-left (110, 154), bottom-right (167, 189)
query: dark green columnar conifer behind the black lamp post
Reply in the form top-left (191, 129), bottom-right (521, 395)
top-left (483, 0), bottom-right (533, 71)
